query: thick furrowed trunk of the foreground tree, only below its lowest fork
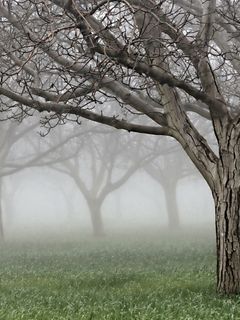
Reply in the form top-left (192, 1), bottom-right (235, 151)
top-left (214, 181), bottom-right (240, 294)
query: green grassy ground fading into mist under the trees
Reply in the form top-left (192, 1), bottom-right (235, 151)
top-left (0, 230), bottom-right (240, 320)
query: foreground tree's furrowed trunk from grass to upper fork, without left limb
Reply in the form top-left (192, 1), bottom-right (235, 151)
top-left (213, 136), bottom-right (240, 294)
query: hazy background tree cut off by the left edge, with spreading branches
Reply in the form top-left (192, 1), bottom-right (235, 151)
top-left (0, 119), bottom-right (83, 241)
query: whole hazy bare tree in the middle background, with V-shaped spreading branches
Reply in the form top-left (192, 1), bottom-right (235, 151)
top-left (52, 128), bottom-right (156, 236)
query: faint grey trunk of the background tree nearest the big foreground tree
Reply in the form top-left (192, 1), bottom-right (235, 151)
top-left (163, 181), bottom-right (180, 230)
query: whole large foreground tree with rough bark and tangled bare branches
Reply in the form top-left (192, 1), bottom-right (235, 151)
top-left (0, 0), bottom-right (240, 293)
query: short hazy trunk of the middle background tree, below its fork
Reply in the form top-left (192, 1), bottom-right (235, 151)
top-left (88, 200), bottom-right (104, 237)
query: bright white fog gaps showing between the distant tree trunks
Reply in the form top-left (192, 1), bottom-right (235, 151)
top-left (9, 168), bottom-right (214, 234)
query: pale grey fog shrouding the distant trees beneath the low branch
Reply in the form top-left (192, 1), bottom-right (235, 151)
top-left (1, 119), bottom-right (214, 241)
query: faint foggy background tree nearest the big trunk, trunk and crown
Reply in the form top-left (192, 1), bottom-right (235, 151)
top-left (144, 120), bottom-right (215, 230)
